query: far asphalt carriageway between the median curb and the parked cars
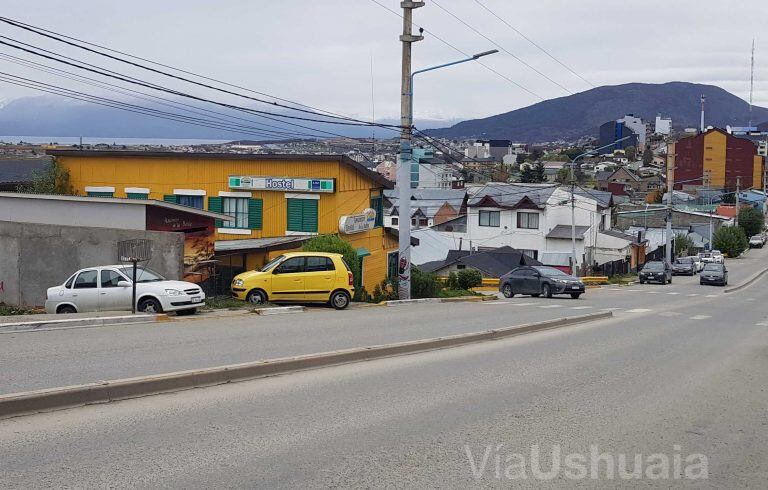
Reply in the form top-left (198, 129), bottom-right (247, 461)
top-left (0, 250), bottom-right (768, 394)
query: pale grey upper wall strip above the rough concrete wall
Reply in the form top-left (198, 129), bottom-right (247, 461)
top-left (0, 195), bottom-right (146, 230)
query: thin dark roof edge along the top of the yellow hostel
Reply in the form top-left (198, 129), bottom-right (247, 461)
top-left (45, 150), bottom-right (395, 189)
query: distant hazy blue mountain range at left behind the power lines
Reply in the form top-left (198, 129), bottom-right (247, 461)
top-left (0, 95), bottom-right (453, 141)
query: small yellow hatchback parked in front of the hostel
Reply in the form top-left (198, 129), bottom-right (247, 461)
top-left (231, 252), bottom-right (355, 310)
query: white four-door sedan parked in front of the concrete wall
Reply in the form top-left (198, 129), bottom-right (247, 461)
top-left (45, 265), bottom-right (205, 315)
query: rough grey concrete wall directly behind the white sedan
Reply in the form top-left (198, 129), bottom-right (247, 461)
top-left (0, 221), bottom-right (184, 306)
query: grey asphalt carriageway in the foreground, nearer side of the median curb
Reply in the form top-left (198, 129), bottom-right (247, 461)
top-left (0, 262), bottom-right (768, 488)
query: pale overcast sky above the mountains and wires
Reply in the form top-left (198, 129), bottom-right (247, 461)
top-left (0, 0), bottom-right (768, 119)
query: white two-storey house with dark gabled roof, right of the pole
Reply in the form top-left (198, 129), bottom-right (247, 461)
top-left (465, 183), bottom-right (613, 264)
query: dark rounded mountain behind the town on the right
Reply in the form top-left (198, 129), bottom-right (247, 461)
top-left (426, 82), bottom-right (768, 143)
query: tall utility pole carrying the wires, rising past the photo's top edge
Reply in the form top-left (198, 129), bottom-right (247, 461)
top-left (397, 0), bottom-right (424, 299)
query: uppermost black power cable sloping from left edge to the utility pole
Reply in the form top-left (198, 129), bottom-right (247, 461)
top-left (0, 17), bottom-right (401, 129)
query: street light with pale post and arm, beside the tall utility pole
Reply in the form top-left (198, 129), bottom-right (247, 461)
top-left (397, 49), bottom-right (499, 299)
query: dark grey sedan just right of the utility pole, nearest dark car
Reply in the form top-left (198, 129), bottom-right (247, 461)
top-left (499, 265), bottom-right (586, 299)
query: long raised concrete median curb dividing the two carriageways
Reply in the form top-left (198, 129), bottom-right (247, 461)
top-left (0, 312), bottom-right (613, 418)
